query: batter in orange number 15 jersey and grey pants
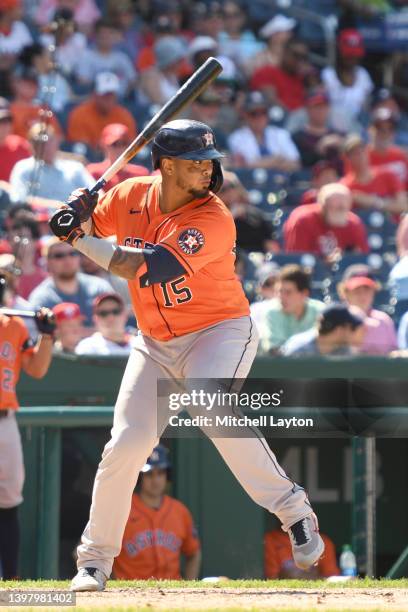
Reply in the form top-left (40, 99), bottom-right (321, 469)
top-left (50, 120), bottom-right (324, 591)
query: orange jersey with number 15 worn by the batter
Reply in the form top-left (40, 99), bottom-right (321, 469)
top-left (92, 176), bottom-right (249, 341)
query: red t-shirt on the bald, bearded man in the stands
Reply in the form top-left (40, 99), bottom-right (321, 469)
top-left (283, 204), bottom-right (369, 256)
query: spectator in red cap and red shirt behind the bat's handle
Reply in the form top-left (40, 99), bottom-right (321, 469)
top-left (86, 123), bottom-right (149, 191)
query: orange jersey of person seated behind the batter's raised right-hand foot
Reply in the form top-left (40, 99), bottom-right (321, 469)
top-left (264, 529), bottom-right (340, 578)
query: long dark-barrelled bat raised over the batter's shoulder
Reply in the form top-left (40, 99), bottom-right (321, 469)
top-left (91, 57), bottom-right (222, 194)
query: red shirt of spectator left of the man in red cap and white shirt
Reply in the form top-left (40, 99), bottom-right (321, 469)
top-left (250, 66), bottom-right (305, 110)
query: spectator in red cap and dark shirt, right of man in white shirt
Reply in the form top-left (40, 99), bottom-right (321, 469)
top-left (292, 89), bottom-right (343, 167)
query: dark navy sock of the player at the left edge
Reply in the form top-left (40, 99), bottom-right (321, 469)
top-left (0, 506), bottom-right (20, 580)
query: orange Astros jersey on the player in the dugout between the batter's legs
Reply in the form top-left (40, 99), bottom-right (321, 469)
top-left (113, 494), bottom-right (200, 580)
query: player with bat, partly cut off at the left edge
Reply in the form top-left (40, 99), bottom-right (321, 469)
top-left (0, 276), bottom-right (55, 580)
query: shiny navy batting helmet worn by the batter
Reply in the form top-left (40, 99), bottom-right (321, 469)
top-left (152, 119), bottom-right (224, 192)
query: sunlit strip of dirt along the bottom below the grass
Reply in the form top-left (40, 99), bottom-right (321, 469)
top-left (72, 587), bottom-right (408, 612)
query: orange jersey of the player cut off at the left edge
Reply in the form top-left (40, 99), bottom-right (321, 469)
top-left (0, 314), bottom-right (33, 410)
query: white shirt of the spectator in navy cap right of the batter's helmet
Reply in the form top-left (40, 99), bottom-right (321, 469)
top-left (228, 125), bottom-right (299, 163)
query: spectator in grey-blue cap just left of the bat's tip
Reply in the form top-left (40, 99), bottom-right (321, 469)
top-left (140, 36), bottom-right (187, 104)
